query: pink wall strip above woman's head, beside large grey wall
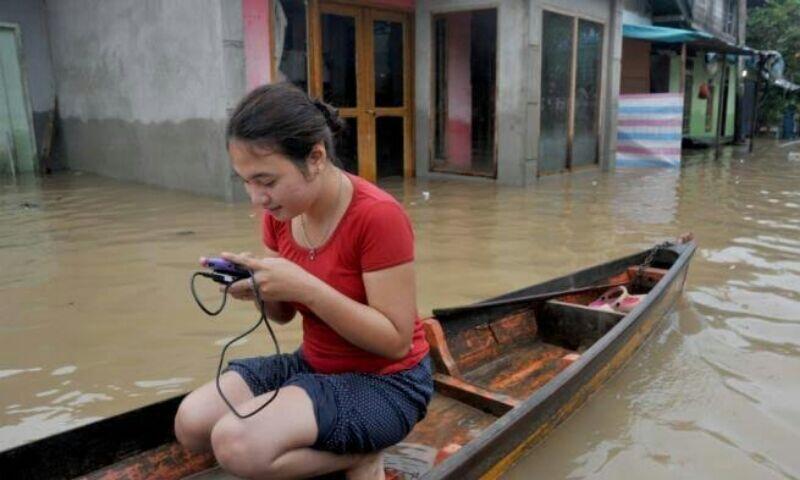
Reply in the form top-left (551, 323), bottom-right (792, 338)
top-left (242, 0), bottom-right (271, 91)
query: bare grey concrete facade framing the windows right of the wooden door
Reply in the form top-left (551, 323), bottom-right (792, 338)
top-left (415, 0), bottom-right (622, 185)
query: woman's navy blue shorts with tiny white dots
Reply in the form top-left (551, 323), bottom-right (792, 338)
top-left (226, 350), bottom-right (433, 454)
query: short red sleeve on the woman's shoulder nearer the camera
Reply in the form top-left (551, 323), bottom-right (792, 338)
top-left (361, 202), bottom-right (414, 272)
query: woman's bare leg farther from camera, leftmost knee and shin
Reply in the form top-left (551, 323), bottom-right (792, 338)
top-left (175, 372), bottom-right (253, 452)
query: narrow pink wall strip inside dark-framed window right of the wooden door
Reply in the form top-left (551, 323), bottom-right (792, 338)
top-left (445, 12), bottom-right (472, 168)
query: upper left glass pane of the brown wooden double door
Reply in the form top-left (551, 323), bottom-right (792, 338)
top-left (322, 13), bottom-right (356, 107)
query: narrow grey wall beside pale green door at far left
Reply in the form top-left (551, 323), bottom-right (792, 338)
top-left (0, 0), bottom-right (55, 157)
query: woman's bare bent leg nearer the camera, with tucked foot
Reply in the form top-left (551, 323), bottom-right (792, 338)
top-left (211, 386), bottom-right (383, 480)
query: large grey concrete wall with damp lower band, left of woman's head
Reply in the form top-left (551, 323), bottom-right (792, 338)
top-left (46, 0), bottom-right (245, 199)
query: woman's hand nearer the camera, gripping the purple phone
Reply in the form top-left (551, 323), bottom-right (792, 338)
top-left (222, 252), bottom-right (320, 304)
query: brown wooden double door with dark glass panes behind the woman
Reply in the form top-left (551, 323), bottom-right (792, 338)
top-left (309, 2), bottom-right (414, 181)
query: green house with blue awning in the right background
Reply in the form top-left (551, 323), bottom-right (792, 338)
top-left (620, 0), bottom-right (755, 148)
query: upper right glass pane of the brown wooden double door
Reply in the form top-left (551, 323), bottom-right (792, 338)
top-left (372, 20), bottom-right (403, 107)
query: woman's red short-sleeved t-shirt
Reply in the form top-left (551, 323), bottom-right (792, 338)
top-left (263, 175), bottom-right (428, 374)
